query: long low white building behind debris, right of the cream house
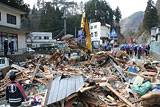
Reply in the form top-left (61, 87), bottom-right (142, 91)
top-left (27, 32), bottom-right (56, 48)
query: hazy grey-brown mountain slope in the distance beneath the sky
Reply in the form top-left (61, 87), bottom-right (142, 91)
top-left (120, 11), bottom-right (144, 36)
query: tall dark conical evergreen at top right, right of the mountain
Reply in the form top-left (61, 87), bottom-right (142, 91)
top-left (143, 0), bottom-right (159, 31)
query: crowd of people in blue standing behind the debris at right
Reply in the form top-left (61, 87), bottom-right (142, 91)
top-left (121, 44), bottom-right (150, 59)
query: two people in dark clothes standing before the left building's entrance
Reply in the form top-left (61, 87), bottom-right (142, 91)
top-left (3, 38), bottom-right (14, 56)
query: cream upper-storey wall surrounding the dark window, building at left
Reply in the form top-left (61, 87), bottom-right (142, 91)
top-left (0, 5), bottom-right (21, 28)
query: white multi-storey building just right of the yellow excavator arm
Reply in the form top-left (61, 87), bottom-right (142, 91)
top-left (89, 22), bottom-right (111, 46)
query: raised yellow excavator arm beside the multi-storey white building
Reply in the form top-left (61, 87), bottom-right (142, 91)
top-left (81, 13), bottom-right (92, 55)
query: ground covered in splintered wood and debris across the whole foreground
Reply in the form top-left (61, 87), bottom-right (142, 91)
top-left (0, 50), bottom-right (160, 107)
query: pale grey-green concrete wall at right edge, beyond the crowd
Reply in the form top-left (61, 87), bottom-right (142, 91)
top-left (151, 42), bottom-right (160, 60)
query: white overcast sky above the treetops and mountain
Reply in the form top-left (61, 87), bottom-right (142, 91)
top-left (24, 0), bottom-right (157, 18)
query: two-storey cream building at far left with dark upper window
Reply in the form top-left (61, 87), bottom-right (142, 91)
top-left (0, 3), bottom-right (26, 52)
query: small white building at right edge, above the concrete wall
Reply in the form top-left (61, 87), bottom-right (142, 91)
top-left (151, 27), bottom-right (160, 41)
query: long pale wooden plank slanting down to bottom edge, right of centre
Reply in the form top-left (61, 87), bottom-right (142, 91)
top-left (100, 82), bottom-right (134, 107)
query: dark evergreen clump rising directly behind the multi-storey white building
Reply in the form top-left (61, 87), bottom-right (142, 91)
top-left (85, 0), bottom-right (114, 26)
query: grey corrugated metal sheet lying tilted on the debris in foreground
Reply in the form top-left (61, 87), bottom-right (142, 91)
top-left (47, 75), bottom-right (84, 105)
